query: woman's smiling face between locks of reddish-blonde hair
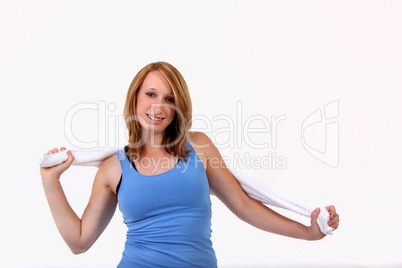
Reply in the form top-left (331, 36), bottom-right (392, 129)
top-left (136, 71), bottom-right (175, 134)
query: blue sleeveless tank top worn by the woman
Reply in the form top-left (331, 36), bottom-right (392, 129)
top-left (117, 144), bottom-right (217, 268)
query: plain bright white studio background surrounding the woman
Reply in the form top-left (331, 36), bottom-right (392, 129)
top-left (0, 0), bottom-right (402, 267)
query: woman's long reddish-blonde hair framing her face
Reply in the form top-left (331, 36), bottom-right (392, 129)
top-left (123, 61), bottom-right (192, 161)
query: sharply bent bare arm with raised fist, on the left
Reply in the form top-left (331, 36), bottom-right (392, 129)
top-left (41, 148), bottom-right (121, 254)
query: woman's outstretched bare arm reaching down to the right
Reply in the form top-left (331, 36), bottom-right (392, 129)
top-left (192, 133), bottom-right (339, 240)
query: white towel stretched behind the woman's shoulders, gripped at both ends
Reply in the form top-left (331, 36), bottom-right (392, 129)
top-left (38, 149), bottom-right (334, 234)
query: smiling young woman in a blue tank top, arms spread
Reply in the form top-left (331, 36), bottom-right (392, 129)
top-left (40, 62), bottom-right (339, 268)
